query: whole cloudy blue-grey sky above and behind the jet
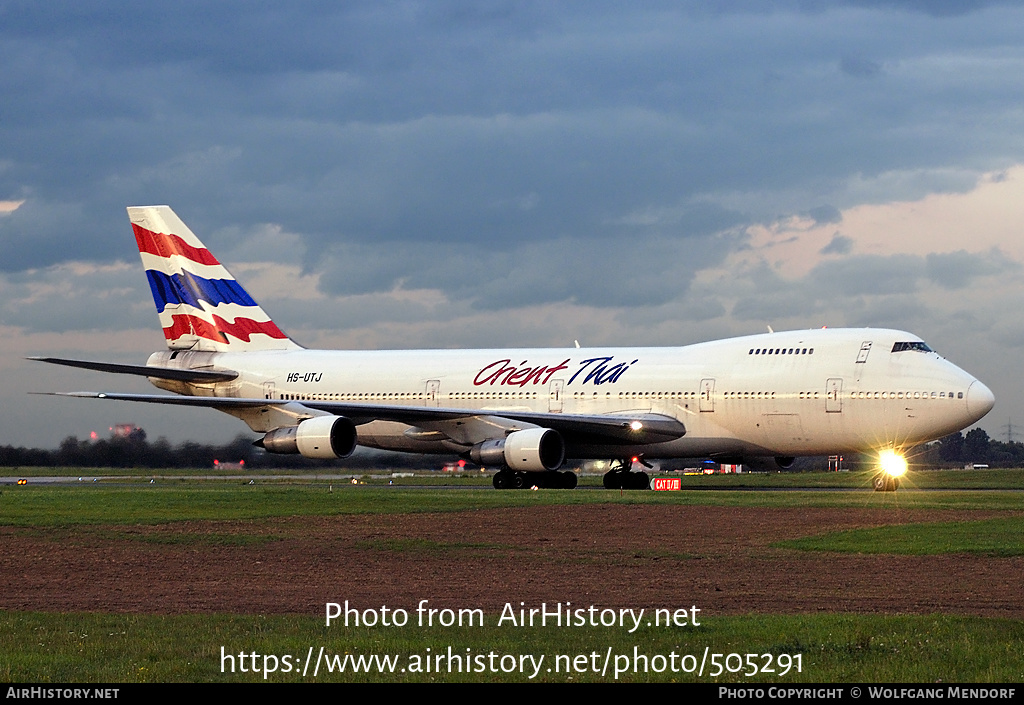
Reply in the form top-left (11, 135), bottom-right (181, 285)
top-left (0, 0), bottom-right (1024, 447)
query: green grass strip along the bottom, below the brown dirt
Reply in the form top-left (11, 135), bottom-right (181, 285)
top-left (0, 613), bottom-right (1024, 682)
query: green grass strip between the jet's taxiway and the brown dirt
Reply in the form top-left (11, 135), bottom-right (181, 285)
top-left (6, 482), bottom-right (1024, 527)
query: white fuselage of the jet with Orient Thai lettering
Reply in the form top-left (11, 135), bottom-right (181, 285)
top-left (150, 328), bottom-right (993, 458)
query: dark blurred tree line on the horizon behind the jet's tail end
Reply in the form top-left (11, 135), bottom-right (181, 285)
top-left (0, 428), bottom-right (456, 470)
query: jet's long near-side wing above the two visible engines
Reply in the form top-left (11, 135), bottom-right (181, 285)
top-left (50, 391), bottom-right (686, 445)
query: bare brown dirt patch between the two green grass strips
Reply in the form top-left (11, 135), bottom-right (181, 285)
top-left (0, 504), bottom-right (1024, 619)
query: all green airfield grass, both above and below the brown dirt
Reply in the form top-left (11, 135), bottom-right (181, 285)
top-left (0, 470), bottom-right (1024, 682)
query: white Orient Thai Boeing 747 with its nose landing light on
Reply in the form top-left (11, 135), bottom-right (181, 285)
top-left (35, 206), bottom-right (994, 489)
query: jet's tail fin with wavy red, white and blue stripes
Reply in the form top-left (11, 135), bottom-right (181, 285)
top-left (128, 206), bottom-right (300, 353)
